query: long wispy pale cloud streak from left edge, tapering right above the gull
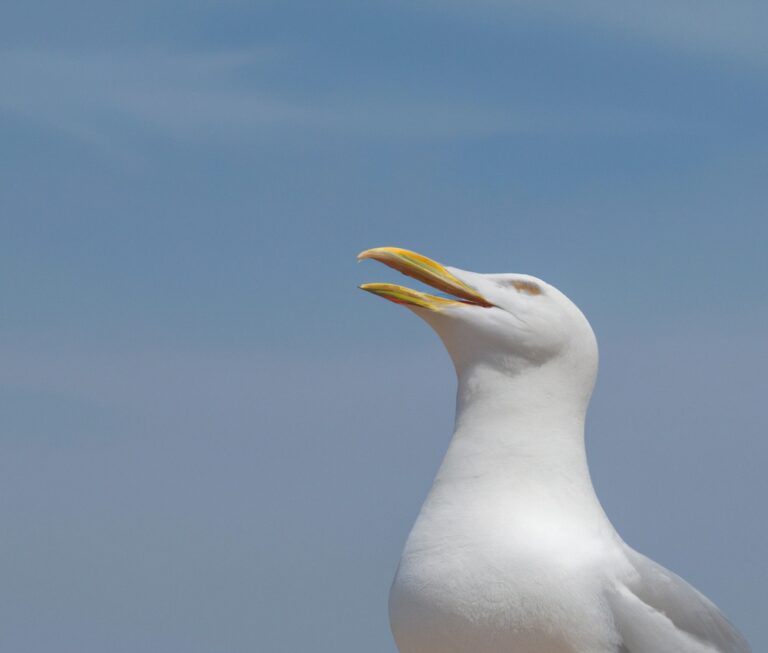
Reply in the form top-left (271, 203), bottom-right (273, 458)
top-left (0, 50), bottom-right (672, 152)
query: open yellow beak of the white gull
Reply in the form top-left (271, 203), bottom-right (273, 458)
top-left (357, 247), bottom-right (493, 311)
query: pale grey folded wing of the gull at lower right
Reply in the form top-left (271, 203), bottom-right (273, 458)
top-left (609, 547), bottom-right (751, 653)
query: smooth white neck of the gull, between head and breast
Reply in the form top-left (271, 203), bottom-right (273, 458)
top-left (426, 361), bottom-right (602, 515)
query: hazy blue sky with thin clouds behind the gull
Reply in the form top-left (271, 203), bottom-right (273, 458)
top-left (0, 0), bottom-right (768, 653)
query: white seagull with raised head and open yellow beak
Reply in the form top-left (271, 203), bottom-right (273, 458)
top-left (358, 247), bottom-right (750, 653)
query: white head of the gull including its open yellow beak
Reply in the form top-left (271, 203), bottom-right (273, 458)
top-left (358, 247), bottom-right (598, 398)
